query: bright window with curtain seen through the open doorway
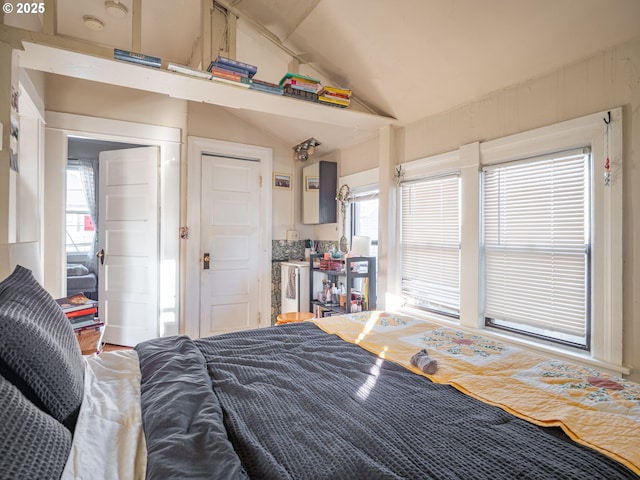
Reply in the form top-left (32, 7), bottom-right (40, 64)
top-left (66, 164), bottom-right (95, 253)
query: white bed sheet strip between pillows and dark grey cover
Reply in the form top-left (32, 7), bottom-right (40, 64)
top-left (62, 350), bottom-right (147, 480)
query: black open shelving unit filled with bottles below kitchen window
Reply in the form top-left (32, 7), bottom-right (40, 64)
top-left (309, 254), bottom-right (376, 316)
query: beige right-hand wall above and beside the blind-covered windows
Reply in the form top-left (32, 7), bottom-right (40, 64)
top-left (341, 34), bottom-right (640, 381)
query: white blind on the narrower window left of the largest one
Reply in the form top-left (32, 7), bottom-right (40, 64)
top-left (400, 174), bottom-right (460, 318)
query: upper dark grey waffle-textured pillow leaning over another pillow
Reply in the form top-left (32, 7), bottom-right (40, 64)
top-left (0, 265), bottom-right (84, 432)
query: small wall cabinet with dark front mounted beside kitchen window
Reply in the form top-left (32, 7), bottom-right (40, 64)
top-left (302, 160), bottom-right (338, 224)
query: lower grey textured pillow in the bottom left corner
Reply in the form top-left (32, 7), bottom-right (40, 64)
top-left (0, 377), bottom-right (71, 478)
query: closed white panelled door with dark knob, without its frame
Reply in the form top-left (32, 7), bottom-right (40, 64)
top-left (200, 155), bottom-right (261, 337)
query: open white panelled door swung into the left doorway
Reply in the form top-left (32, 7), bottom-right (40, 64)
top-left (98, 147), bottom-right (160, 346)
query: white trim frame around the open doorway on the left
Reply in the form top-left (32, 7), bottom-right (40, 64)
top-left (43, 112), bottom-right (182, 340)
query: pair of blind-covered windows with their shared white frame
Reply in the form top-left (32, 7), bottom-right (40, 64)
top-left (389, 109), bottom-right (628, 373)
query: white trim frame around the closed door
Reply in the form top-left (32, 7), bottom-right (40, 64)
top-left (185, 136), bottom-right (273, 338)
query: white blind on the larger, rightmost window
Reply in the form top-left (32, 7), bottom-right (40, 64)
top-left (483, 149), bottom-right (590, 349)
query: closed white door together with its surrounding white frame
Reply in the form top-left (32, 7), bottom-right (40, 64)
top-left (185, 137), bottom-right (273, 338)
